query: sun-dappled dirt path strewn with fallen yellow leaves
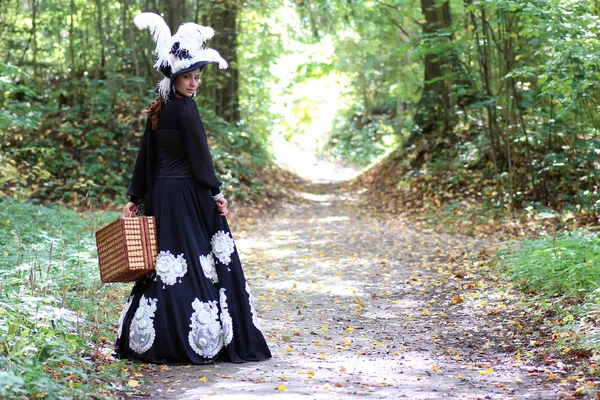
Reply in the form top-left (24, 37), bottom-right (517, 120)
top-left (139, 185), bottom-right (559, 400)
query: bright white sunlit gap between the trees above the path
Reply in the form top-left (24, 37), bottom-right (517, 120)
top-left (270, 22), bottom-right (358, 181)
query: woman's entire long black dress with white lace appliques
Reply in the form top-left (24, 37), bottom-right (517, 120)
top-left (115, 97), bottom-right (271, 364)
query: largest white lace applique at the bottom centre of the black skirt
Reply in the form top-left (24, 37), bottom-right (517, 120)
top-left (188, 299), bottom-right (223, 358)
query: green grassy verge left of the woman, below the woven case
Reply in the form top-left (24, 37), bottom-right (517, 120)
top-left (0, 198), bottom-right (137, 399)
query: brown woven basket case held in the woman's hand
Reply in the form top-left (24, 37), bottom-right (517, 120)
top-left (96, 216), bottom-right (158, 283)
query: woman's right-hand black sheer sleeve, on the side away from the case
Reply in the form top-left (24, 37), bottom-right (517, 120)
top-left (181, 98), bottom-right (222, 196)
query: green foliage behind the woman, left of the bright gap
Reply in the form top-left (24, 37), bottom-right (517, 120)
top-left (0, 0), bottom-right (278, 206)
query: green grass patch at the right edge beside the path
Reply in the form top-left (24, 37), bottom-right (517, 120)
top-left (497, 230), bottom-right (600, 362)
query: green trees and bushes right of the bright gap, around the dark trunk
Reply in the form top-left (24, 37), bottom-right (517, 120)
top-left (290, 0), bottom-right (600, 214)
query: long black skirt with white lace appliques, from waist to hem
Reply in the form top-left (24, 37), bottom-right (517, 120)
top-left (115, 178), bottom-right (271, 364)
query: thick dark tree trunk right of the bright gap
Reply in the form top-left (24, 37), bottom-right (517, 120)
top-left (415, 0), bottom-right (452, 134)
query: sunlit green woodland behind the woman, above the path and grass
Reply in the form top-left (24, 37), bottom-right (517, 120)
top-left (0, 0), bottom-right (600, 214)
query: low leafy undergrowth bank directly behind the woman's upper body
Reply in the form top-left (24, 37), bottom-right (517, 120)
top-left (0, 75), bottom-right (270, 206)
